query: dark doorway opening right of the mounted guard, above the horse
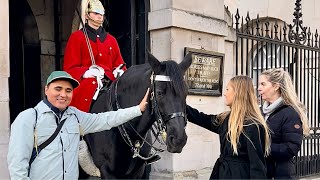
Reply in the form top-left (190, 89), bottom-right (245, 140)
top-left (102, 0), bottom-right (149, 67)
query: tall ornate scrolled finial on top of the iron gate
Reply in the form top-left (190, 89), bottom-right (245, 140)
top-left (288, 0), bottom-right (307, 44)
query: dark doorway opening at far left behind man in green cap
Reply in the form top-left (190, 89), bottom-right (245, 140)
top-left (9, 0), bottom-right (41, 123)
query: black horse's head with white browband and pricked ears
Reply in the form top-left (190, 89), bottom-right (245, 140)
top-left (148, 53), bottom-right (192, 153)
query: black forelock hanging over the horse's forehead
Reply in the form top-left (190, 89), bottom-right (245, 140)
top-left (161, 60), bottom-right (187, 94)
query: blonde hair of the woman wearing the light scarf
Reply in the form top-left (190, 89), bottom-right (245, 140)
top-left (261, 68), bottom-right (310, 136)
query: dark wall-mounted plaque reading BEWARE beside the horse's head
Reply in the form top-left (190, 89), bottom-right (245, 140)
top-left (184, 47), bottom-right (224, 96)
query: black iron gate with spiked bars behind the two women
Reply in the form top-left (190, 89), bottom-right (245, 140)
top-left (234, 0), bottom-right (320, 177)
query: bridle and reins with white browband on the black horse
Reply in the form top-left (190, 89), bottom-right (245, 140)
top-left (115, 72), bottom-right (187, 160)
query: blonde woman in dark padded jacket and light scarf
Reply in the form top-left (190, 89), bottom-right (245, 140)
top-left (258, 69), bottom-right (309, 179)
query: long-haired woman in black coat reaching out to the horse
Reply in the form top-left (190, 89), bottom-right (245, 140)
top-left (187, 76), bottom-right (270, 179)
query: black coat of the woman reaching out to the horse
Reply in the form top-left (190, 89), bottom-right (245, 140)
top-left (187, 106), bottom-right (267, 179)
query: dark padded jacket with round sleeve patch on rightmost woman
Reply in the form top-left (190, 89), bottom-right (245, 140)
top-left (266, 105), bottom-right (303, 179)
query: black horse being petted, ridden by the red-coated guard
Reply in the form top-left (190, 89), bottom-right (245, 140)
top-left (80, 53), bottom-right (192, 179)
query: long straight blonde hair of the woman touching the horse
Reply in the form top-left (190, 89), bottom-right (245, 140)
top-left (220, 76), bottom-right (271, 156)
